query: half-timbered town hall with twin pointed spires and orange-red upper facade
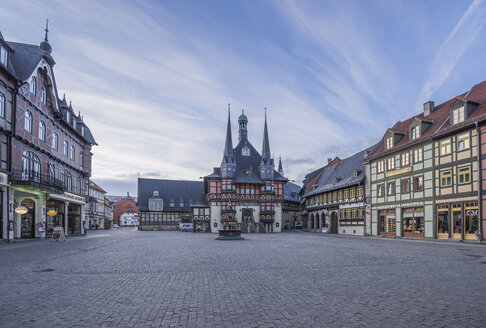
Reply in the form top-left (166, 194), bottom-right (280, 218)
top-left (204, 109), bottom-right (288, 232)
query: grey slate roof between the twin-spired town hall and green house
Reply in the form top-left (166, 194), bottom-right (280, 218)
top-left (303, 147), bottom-right (373, 197)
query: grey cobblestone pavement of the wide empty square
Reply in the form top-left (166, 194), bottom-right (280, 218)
top-left (0, 230), bottom-right (486, 327)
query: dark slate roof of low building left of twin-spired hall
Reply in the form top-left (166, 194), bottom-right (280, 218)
top-left (138, 178), bottom-right (208, 212)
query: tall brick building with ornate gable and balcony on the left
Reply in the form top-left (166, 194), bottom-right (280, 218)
top-left (0, 26), bottom-right (96, 238)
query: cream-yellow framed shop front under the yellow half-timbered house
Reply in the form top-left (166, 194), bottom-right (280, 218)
top-left (436, 202), bottom-right (479, 240)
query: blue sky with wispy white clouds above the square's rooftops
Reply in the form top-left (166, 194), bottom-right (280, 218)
top-left (0, 0), bottom-right (486, 195)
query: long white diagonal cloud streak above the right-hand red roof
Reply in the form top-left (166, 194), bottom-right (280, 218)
top-left (415, 0), bottom-right (486, 108)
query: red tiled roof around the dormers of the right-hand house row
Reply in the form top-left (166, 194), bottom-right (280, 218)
top-left (371, 81), bottom-right (486, 160)
